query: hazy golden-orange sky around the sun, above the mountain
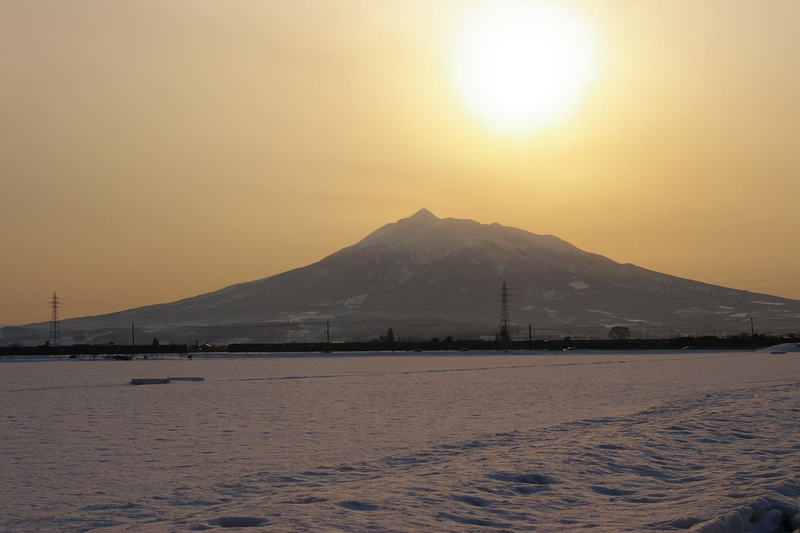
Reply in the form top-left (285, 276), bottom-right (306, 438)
top-left (0, 0), bottom-right (800, 325)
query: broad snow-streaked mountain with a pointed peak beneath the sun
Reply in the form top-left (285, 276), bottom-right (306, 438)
top-left (6, 209), bottom-right (800, 342)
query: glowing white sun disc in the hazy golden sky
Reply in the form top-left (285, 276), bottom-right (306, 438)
top-left (453, 0), bottom-right (597, 134)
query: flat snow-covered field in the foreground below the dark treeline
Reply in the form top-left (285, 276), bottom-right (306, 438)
top-left (0, 352), bottom-right (800, 533)
